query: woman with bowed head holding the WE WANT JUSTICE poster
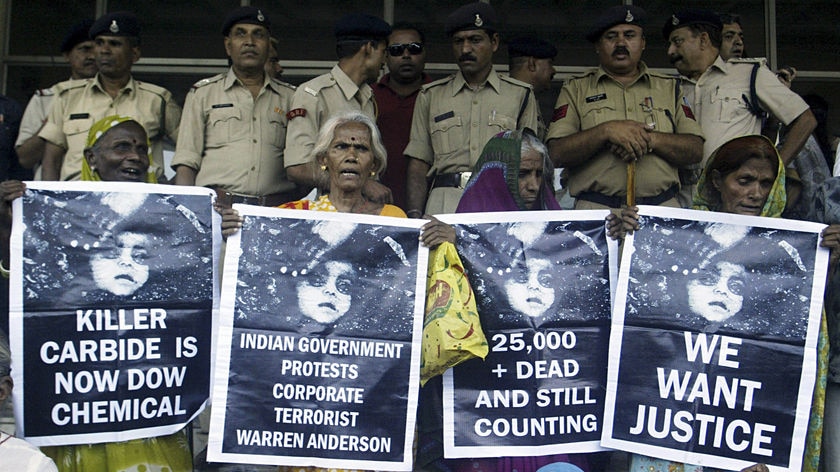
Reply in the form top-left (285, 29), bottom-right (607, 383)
top-left (607, 135), bottom-right (840, 472)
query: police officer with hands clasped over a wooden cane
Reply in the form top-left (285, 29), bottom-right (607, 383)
top-left (548, 6), bottom-right (703, 209)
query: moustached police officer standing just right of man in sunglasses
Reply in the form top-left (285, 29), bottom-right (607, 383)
top-left (404, 2), bottom-right (538, 218)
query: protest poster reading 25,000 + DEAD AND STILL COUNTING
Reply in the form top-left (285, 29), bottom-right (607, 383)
top-left (441, 210), bottom-right (617, 458)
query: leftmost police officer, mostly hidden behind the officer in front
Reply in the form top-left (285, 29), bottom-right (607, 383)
top-left (15, 19), bottom-right (96, 179)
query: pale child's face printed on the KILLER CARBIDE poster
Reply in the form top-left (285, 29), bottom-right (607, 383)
top-left (90, 232), bottom-right (149, 297)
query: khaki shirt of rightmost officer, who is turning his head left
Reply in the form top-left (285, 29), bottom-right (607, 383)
top-left (693, 56), bottom-right (808, 160)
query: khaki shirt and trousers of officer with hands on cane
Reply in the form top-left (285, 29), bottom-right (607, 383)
top-left (547, 63), bottom-right (703, 209)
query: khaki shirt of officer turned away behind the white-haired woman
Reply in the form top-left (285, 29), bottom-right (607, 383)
top-left (285, 65), bottom-right (376, 167)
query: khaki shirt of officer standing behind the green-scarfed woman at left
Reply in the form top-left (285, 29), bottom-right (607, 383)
top-left (38, 74), bottom-right (181, 180)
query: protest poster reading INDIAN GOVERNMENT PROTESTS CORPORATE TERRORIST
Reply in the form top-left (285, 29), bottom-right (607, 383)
top-left (208, 205), bottom-right (428, 470)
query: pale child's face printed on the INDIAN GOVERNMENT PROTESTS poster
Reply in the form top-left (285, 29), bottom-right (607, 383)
top-left (297, 261), bottom-right (356, 323)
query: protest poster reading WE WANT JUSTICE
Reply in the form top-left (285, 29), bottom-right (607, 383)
top-left (602, 207), bottom-right (828, 471)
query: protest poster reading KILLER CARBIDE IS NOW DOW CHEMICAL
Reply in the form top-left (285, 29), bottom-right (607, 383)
top-left (10, 182), bottom-right (220, 446)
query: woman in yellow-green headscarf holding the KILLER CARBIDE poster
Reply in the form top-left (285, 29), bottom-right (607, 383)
top-left (0, 116), bottom-right (192, 472)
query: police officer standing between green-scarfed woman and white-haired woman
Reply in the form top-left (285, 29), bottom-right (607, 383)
top-left (172, 6), bottom-right (300, 206)
